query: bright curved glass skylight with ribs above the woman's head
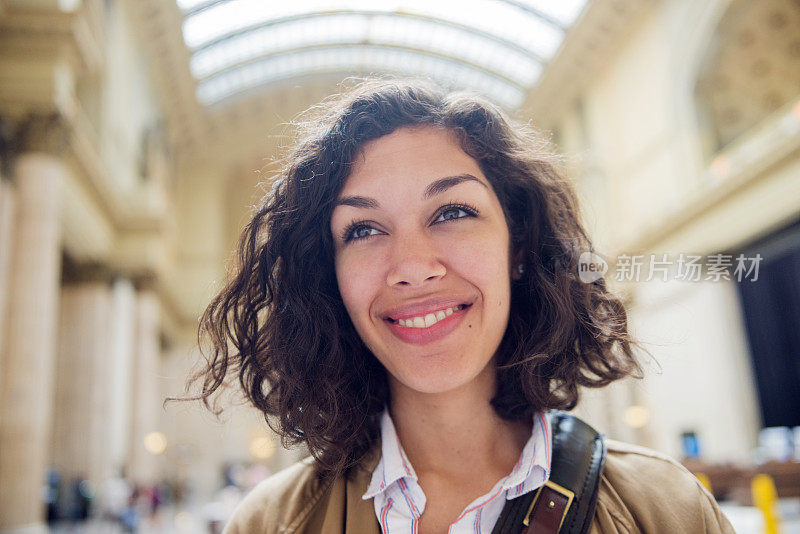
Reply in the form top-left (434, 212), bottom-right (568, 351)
top-left (177, 0), bottom-right (586, 108)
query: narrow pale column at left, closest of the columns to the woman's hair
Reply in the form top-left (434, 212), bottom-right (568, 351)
top-left (128, 289), bottom-right (162, 484)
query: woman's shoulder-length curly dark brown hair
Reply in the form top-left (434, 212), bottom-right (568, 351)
top-left (190, 79), bottom-right (641, 482)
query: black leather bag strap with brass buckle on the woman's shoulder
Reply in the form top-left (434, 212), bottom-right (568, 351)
top-left (492, 411), bottom-right (606, 534)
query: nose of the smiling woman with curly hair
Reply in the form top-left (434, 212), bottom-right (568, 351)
top-left (386, 235), bottom-right (447, 287)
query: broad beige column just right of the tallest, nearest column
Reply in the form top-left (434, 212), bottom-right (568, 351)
top-left (52, 280), bottom-right (111, 491)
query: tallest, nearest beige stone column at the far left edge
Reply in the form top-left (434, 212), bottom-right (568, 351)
top-left (0, 152), bottom-right (65, 532)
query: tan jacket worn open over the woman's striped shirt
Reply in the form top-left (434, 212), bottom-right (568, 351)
top-left (225, 440), bottom-right (734, 534)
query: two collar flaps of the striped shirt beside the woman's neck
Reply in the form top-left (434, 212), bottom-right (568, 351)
top-left (361, 410), bottom-right (552, 499)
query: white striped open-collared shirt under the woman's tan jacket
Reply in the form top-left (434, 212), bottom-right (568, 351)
top-left (361, 410), bottom-right (552, 534)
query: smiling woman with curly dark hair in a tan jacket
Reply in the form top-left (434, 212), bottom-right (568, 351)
top-left (192, 80), bottom-right (731, 533)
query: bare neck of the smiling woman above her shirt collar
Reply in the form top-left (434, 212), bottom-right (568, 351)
top-left (390, 364), bottom-right (532, 479)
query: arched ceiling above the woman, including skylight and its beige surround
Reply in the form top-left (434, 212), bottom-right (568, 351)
top-left (125, 0), bottom-right (657, 159)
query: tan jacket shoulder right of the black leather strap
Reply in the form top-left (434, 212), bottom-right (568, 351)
top-left (596, 440), bottom-right (734, 534)
